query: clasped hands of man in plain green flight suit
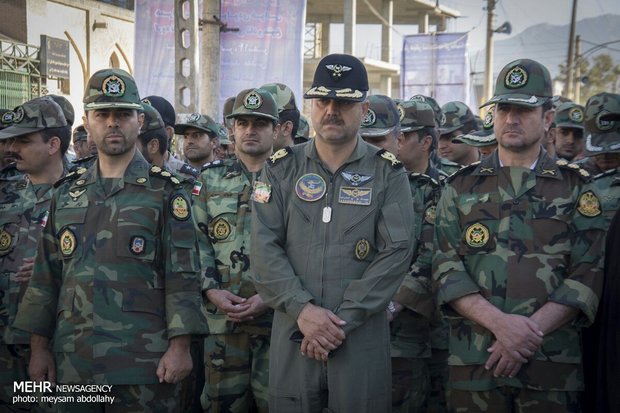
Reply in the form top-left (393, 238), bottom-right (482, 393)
top-left (297, 303), bottom-right (347, 358)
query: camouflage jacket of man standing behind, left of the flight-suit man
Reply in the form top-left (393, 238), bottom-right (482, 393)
top-left (192, 160), bottom-right (273, 334)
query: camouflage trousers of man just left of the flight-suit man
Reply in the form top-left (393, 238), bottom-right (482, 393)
top-left (201, 333), bottom-right (270, 413)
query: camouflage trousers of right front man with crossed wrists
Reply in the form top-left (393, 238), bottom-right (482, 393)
top-left (448, 386), bottom-right (581, 413)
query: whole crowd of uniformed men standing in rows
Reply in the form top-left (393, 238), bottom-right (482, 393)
top-left (0, 54), bottom-right (620, 413)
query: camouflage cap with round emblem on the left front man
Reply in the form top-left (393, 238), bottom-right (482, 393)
top-left (83, 69), bottom-right (142, 111)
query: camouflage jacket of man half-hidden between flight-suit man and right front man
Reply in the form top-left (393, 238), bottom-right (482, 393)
top-left (390, 165), bottom-right (445, 358)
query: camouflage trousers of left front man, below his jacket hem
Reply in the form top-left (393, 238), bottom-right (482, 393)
top-left (47, 383), bottom-right (181, 413)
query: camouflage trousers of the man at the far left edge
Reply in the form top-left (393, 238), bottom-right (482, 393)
top-left (0, 343), bottom-right (34, 412)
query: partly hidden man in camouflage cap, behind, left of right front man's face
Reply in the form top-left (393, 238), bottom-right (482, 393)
top-left (439, 101), bottom-right (480, 174)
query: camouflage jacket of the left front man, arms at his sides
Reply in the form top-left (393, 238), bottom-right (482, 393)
top-left (14, 152), bottom-right (206, 384)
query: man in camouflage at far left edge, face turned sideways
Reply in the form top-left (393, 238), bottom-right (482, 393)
top-left (0, 97), bottom-right (71, 411)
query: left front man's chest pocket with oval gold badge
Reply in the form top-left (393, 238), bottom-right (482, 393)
top-left (54, 206), bottom-right (87, 261)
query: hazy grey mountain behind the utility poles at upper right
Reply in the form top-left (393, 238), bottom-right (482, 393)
top-left (471, 14), bottom-right (620, 78)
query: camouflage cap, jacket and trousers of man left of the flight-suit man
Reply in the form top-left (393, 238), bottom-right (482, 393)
top-left (193, 89), bottom-right (278, 413)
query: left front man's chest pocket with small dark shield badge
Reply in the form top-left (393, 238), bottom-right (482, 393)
top-left (116, 206), bottom-right (159, 262)
